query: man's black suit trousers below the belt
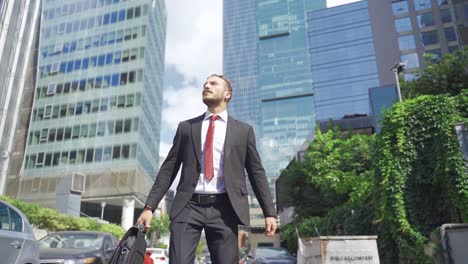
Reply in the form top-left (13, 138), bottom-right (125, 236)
top-left (169, 195), bottom-right (239, 264)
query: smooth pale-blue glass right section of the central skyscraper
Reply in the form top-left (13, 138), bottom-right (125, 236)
top-left (257, 0), bottom-right (326, 185)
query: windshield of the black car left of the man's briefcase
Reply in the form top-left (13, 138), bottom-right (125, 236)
top-left (38, 234), bottom-right (103, 249)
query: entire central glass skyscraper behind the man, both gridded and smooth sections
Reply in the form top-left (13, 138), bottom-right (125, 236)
top-left (223, 0), bottom-right (326, 226)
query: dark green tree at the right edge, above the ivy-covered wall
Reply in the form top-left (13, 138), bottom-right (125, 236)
top-left (401, 46), bottom-right (468, 99)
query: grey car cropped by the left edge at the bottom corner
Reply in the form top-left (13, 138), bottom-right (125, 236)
top-left (0, 201), bottom-right (39, 264)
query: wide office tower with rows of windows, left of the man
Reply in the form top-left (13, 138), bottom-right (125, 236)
top-left (19, 0), bottom-right (166, 227)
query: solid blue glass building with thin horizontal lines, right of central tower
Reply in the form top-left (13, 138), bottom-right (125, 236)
top-left (307, 1), bottom-right (380, 122)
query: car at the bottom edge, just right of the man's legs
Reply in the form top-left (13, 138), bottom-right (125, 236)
top-left (247, 247), bottom-right (296, 264)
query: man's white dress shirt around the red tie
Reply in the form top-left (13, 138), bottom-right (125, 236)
top-left (195, 111), bottom-right (228, 194)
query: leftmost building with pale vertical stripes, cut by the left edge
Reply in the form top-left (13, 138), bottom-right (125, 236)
top-left (0, 0), bottom-right (40, 196)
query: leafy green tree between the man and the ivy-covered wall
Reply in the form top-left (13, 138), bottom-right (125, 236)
top-left (280, 129), bottom-right (375, 251)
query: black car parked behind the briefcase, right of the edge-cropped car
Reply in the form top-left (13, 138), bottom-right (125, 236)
top-left (38, 231), bottom-right (118, 264)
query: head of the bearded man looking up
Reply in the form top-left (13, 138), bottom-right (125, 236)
top-left (202, 76), bottom-right (231, 106)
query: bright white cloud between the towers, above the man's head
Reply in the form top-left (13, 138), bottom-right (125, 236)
top-left (166, 0), bottom-right (223, 84)
